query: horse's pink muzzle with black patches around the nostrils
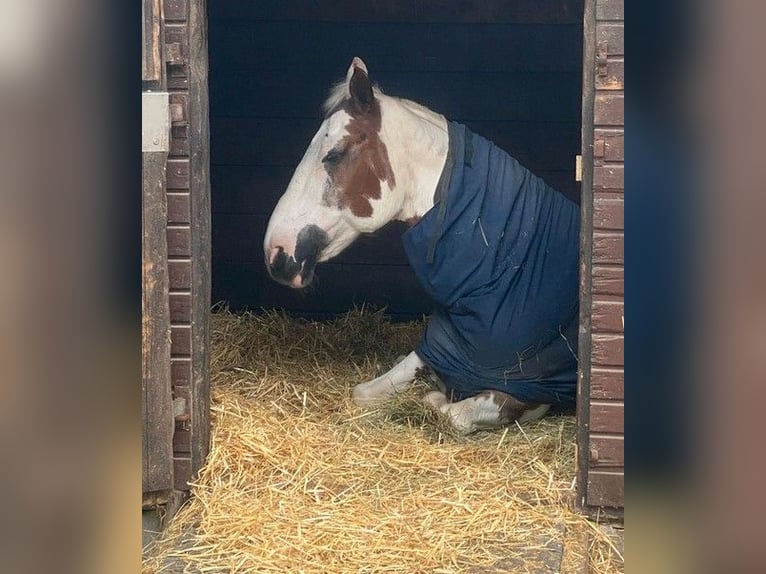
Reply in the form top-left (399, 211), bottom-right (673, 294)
top-left (265, 225), bottom-right (329, 289)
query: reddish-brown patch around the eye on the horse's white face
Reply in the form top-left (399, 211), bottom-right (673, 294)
top-left (323, 99), bottom-right (396, 217)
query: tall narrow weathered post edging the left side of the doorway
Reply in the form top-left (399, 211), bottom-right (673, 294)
top-left (188, 0), bottom-right (211, 486)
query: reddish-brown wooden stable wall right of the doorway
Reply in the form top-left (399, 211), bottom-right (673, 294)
top-left (578, 0), bottom-right (625, 508)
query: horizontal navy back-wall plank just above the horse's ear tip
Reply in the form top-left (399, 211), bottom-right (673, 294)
top-left (210, 20), bottom-right (582, 73)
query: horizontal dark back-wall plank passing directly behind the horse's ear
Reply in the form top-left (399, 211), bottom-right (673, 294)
top-left (211, 70), bottom-right (584, 123)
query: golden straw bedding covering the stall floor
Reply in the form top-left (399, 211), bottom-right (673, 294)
top-left (143, 309), bottom-right (622, 574)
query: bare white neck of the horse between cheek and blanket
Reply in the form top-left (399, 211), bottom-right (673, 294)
top-left (382, 96), bottom-right (449, 224)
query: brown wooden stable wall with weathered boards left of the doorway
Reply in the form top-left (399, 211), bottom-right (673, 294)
top-left (142, 0), bottom-right (210, 500)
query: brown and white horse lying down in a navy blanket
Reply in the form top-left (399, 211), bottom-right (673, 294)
top-left (264, 57), bottom-right (579, 433)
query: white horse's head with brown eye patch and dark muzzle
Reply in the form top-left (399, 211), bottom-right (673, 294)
top-left (264, 58), bottom-right (404, 288)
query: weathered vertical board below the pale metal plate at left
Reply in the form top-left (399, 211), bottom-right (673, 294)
top-left (141, 152), bottom-right (173, 492)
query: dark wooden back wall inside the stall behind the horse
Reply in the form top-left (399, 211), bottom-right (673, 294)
top-left (208, 0), bottom-right (582, 315)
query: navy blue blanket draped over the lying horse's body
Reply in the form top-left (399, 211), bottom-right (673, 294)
top-left (403, 122), bottom-right (580, 407)
